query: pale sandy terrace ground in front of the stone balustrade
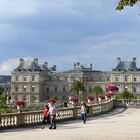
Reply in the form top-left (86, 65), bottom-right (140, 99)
top-left (0, 108), bottom-right (140, 140)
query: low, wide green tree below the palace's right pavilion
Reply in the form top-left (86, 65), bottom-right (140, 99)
top-left (117, 91), bottom-right (136, 99)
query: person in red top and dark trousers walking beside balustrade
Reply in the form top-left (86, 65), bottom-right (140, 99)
top-left (41, 105), bottom-right (50, 129)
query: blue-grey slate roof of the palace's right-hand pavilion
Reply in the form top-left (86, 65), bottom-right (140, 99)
top-left (113, 61), bottom-right (139, 71)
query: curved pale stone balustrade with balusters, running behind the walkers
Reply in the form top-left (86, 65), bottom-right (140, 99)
top-left (0, 100), bottom-right (114, 129)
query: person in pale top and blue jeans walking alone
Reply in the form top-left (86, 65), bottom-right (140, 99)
top-left (80, 102), bottom-right (87, 124)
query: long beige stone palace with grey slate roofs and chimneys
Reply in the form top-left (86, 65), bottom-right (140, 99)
top-left (11, 58), bottom-right (140, 103)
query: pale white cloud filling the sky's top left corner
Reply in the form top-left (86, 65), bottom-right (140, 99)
top-left (0, 0), bottom-right (38, 18)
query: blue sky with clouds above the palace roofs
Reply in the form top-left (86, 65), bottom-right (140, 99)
top-left (0, 0), bottom-right (140, 75)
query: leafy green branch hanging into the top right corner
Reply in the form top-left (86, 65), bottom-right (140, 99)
top-left (116, 0), bottom-right (140, 10)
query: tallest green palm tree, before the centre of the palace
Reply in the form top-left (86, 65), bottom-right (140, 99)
top-left (70, 81), bottom-right (86, 101)
